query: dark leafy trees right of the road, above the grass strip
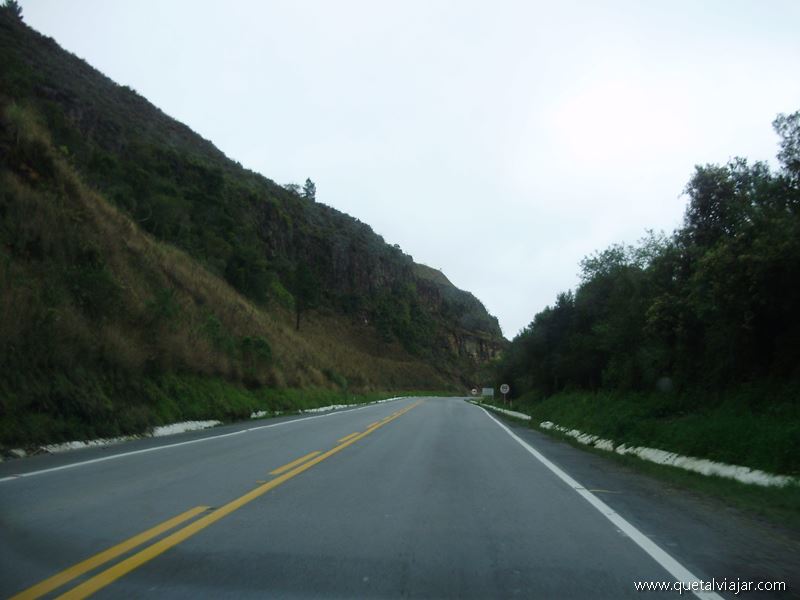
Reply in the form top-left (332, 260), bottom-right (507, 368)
top-left (497, 112), bottom-right (800, 397)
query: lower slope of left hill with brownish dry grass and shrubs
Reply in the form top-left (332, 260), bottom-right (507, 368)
top-left (0, 99), bottom-right (453, 443)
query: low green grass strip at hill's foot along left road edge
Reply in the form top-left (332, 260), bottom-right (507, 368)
top-left (0, 370), bottom-right (450, 450)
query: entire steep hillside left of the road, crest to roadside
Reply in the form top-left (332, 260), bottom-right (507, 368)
top-left (0, 8), bottom-right (504, 447)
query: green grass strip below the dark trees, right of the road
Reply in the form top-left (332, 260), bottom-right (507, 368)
top-left (514, 382), bottom-right (800, 477)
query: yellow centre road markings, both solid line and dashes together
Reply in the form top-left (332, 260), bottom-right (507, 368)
top-left (11, 401), bottom-right (421, 600)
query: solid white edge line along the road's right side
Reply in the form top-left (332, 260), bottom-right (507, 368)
top-left (478, 406), bottom-right (722, 600)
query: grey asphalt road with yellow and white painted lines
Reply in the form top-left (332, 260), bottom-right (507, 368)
top-left (0, 398), bottom-right (800, 598)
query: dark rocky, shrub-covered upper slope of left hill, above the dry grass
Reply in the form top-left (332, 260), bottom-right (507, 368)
top-left (0, 14), bottom-right (502, 370)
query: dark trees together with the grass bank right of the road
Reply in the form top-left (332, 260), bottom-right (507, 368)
top-left (495, 112), bottom-right (800, 475)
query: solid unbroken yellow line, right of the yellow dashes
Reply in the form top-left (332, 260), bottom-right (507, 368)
top-left (59, 400), bottom-right (422, 600)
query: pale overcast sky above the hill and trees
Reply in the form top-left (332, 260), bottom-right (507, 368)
top-left (20, 0), bottom-right (800, 338)
